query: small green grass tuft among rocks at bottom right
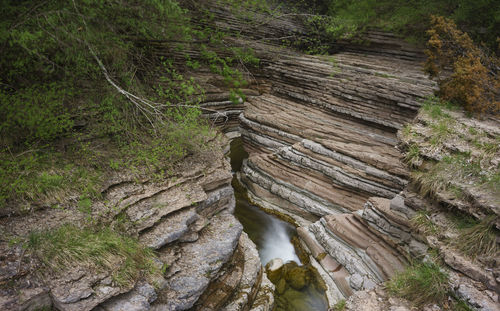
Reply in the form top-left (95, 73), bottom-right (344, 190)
top-left (386, 263), bottom-right (449, 307)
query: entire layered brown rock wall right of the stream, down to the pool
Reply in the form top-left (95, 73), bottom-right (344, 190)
top-left (197, 4), bottom-right (497, 310)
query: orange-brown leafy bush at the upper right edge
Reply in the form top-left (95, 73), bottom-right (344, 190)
top-left (425, 16), bottom-right (500, 113)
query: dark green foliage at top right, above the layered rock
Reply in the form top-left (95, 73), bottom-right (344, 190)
top-left (321, 0), bottom-right (500, 48)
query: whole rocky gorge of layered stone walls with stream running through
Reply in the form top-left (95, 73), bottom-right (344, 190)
top-left (0, 1), bottom-right (500, 311)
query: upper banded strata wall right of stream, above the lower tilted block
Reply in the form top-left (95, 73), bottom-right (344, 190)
top-left (236, 34), bottom-right (434, 229)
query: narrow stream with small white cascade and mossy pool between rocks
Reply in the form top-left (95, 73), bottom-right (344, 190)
top-left (230, 138), bottom-right (328, 311)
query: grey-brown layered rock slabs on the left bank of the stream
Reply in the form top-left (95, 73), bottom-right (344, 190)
top-left (0, 141), bottom-right (274, 311)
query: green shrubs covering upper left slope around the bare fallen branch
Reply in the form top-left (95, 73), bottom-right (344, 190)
top-left (0, 0), bottom-right (219, 212)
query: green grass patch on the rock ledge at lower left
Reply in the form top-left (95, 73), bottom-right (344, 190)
top-left (25, 225), bottom-right (160, 286)
